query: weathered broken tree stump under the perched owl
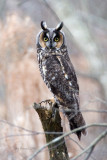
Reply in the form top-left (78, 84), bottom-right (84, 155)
top-left (34, 103), bottom-right (69, 160)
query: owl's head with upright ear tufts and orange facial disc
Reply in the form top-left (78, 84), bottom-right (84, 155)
top-left (37, 21), bottom-right (65, 51)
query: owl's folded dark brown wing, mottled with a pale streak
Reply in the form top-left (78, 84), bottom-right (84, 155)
top-left (45, 56), bottom-right (79, 103)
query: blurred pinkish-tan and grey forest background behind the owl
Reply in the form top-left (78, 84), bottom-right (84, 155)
top-left (0, 0), bottom-right (107, 160)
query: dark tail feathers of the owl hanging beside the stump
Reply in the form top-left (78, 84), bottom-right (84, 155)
top-left (66, 112), bottom-right (87, 140)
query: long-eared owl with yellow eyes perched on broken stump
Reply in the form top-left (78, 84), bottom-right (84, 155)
top-left (36, 21), bottom-right (86, 139)
